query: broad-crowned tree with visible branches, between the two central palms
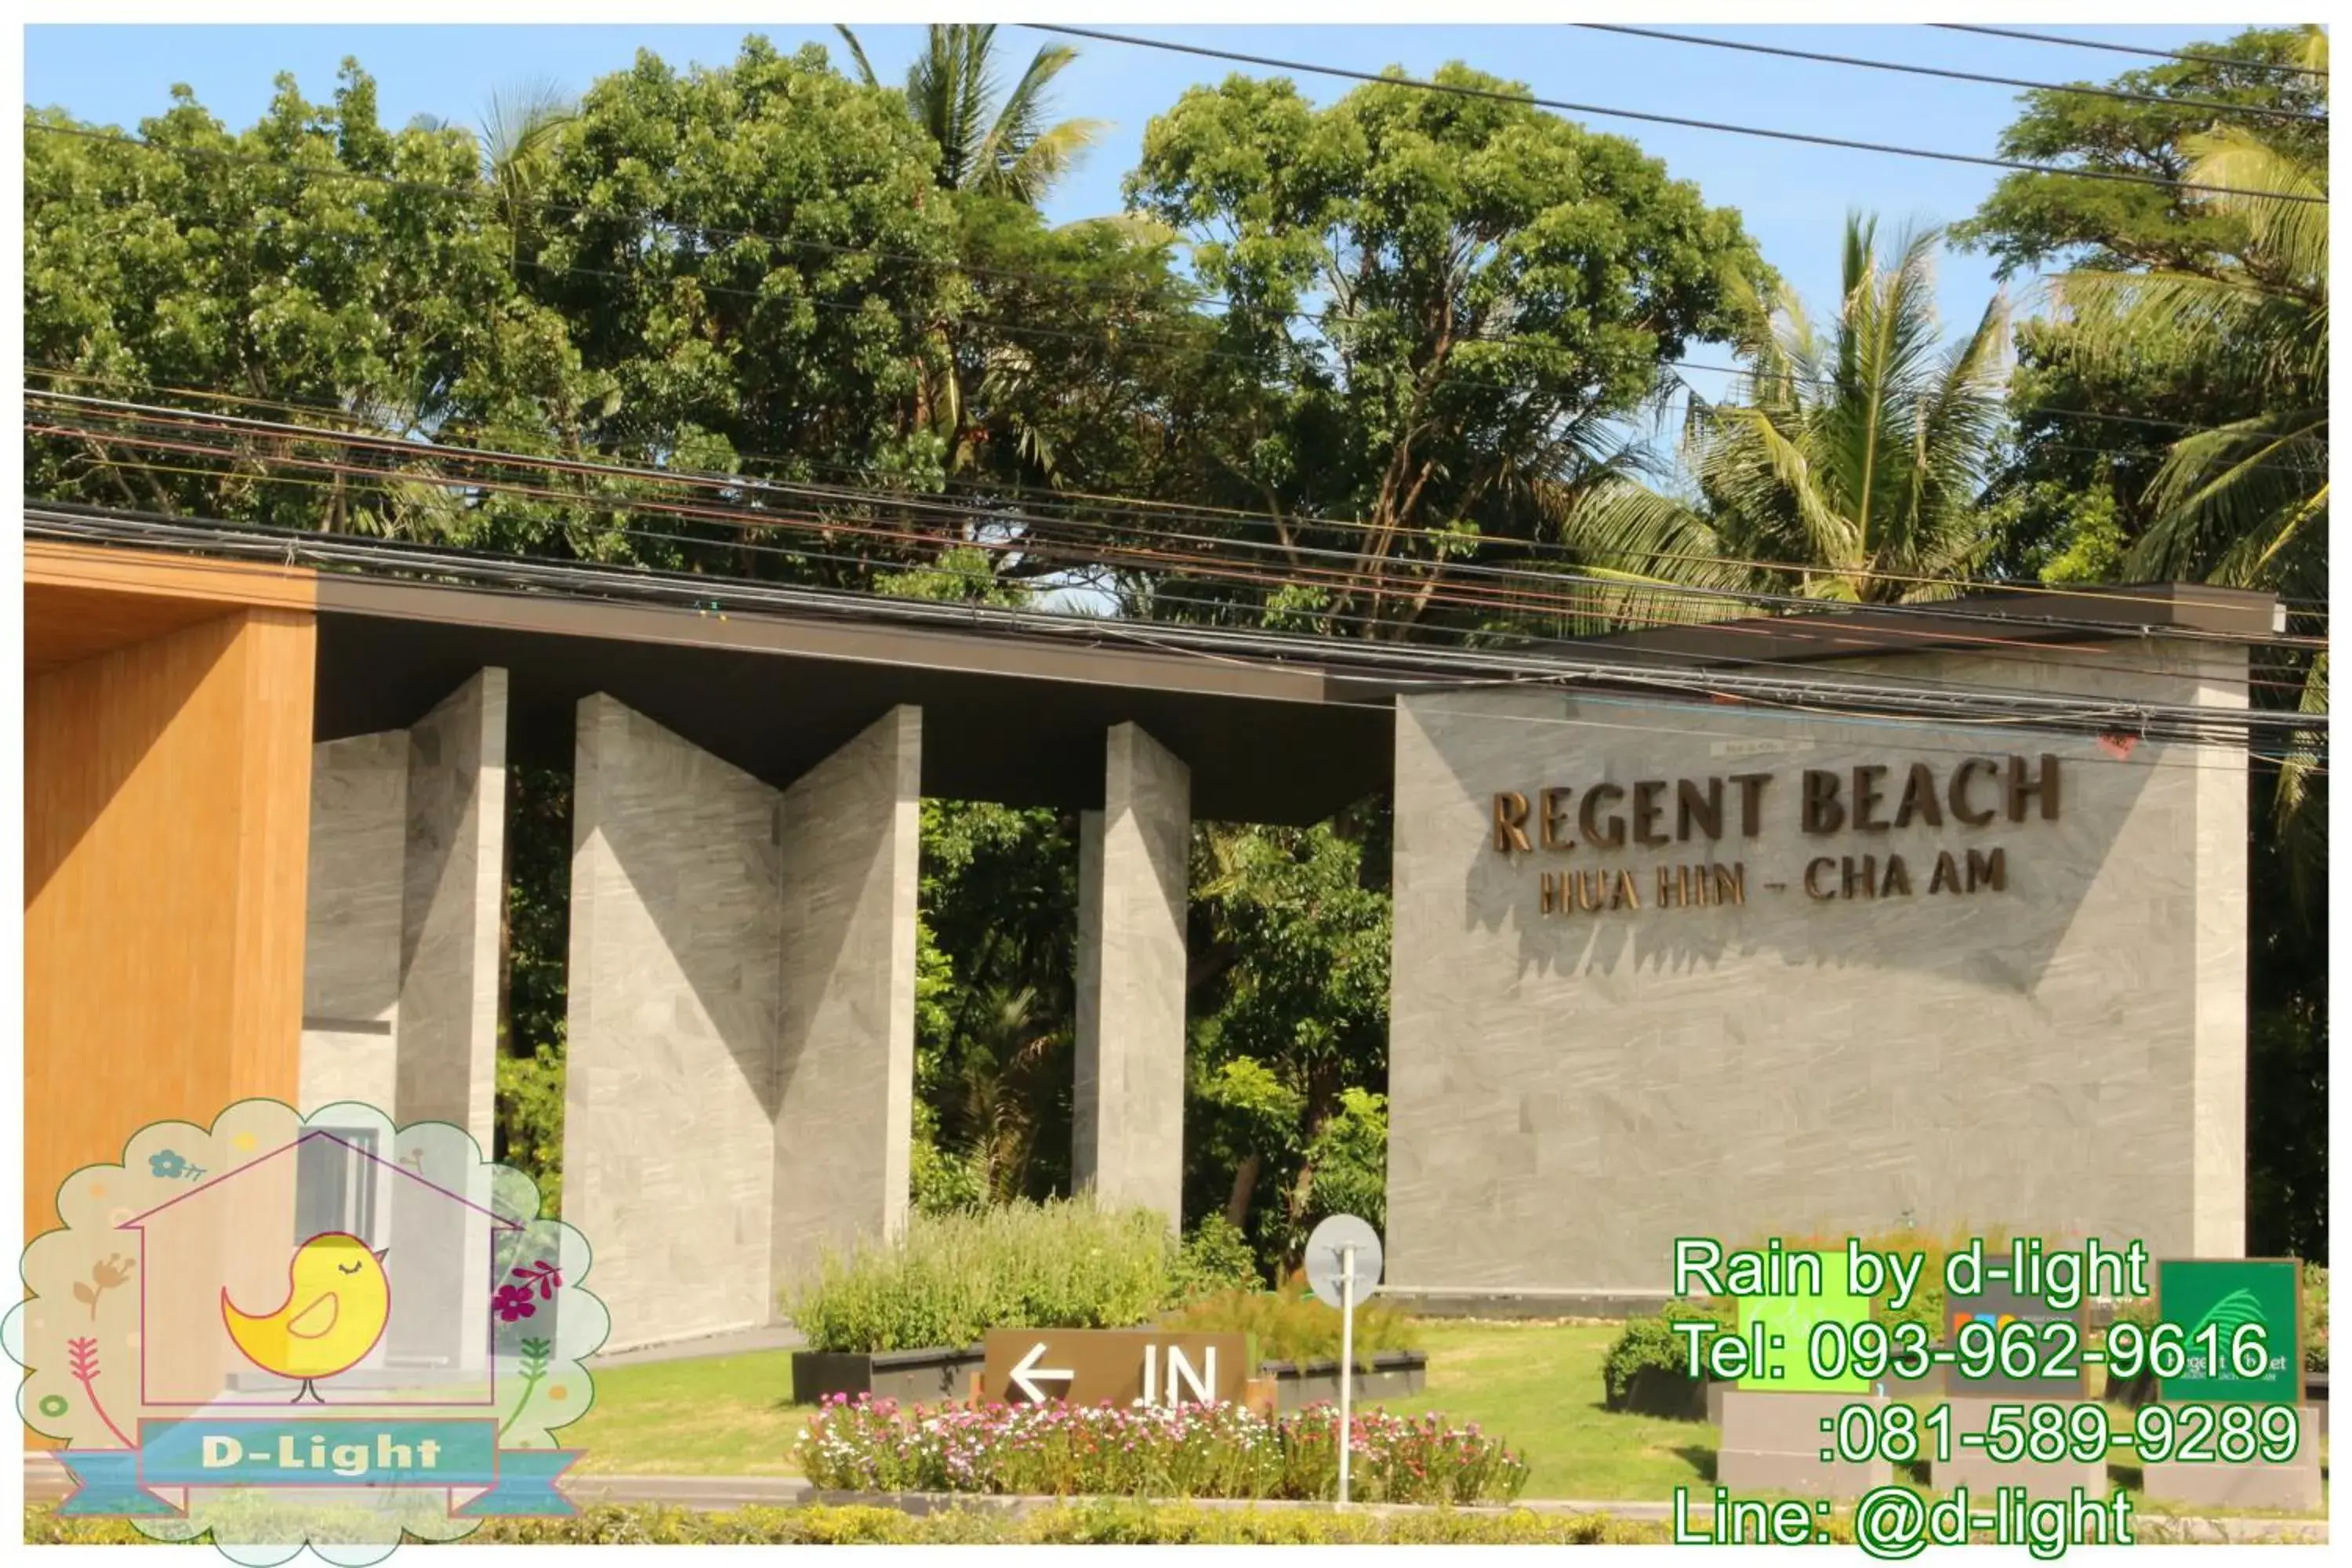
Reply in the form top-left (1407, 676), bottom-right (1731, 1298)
top-left (1127, 66), bottom-right (1764, 637)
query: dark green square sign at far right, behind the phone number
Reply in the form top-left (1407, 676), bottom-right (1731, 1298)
top-left (2157, 1258), bottom-right (2303, 1403)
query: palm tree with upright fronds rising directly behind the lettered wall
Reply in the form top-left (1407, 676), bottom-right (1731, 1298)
top-left (1684, 216), bottom-right (2009, 604)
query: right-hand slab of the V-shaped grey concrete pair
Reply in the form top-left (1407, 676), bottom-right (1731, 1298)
top-left (774, 708), bottom-right (922, 1290)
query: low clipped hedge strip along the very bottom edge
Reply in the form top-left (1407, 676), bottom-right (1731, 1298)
top-left (24, 1497), bottom-right (1668, 1547)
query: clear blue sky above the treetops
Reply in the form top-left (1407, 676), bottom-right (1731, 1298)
top-left (24, 24), bottom-right (2246, 408)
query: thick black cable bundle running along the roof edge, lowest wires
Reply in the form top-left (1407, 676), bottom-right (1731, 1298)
top-left (26, 506), bottom-right (2326, 743)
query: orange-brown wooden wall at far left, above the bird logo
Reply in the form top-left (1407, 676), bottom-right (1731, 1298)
top-left (24, 609), bottom-right (318, 1236)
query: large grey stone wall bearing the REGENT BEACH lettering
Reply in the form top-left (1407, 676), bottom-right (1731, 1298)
top-left (1388, 642), bottom-right (2246, 1298)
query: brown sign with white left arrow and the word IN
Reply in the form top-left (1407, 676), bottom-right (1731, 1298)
top-left (981, 1328), bottom-right (1256, 1406)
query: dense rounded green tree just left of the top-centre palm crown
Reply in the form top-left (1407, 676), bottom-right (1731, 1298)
top-left (527, 38), bottom-right (962, 581)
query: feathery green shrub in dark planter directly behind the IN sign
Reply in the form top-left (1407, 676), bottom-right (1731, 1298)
top-left (786, 1199), bottom-right (1176, 1352)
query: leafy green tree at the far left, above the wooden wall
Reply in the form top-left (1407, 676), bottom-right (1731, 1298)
top-left (24, 61), bottom-right (595, 532)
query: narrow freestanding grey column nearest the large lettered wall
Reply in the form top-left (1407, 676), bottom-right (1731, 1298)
top-left (1070, 724), bottom-right (1192, 1229)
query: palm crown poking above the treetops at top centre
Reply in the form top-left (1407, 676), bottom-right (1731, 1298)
top-left (835, 21), bottom-right (1105, 207)
